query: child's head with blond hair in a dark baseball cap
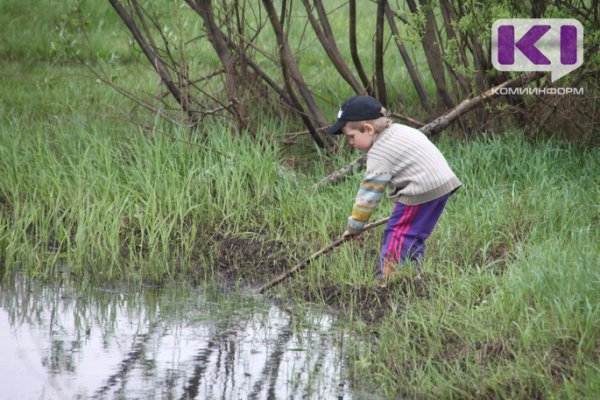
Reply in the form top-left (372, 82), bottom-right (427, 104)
top-left (325, 96), bottom-right (392, 152)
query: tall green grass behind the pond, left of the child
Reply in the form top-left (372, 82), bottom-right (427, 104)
top-left (0, 61), bottom-right (352, 281)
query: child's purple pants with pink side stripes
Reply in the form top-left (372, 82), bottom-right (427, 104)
top-left (377, 193), bottom-right (452, 279)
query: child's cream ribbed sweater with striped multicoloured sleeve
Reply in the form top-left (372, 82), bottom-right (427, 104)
top-left (347, 124), bottom-right (461, 234)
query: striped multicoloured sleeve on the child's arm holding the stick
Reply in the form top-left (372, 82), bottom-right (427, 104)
top-left (346, 171), bottom-right (392, 235)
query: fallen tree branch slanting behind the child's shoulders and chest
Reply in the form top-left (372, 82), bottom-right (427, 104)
top-left (315, 72), bottom-right (543, 188)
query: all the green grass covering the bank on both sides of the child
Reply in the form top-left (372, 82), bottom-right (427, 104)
top-left (0, 2), bottom-right (600, 399)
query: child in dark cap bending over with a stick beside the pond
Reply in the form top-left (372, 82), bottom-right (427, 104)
top-left (326, 96), bottom-right (461, 279)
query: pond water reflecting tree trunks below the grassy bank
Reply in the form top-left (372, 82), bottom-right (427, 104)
top-left (0, 279), bottom-right (370, 400)
